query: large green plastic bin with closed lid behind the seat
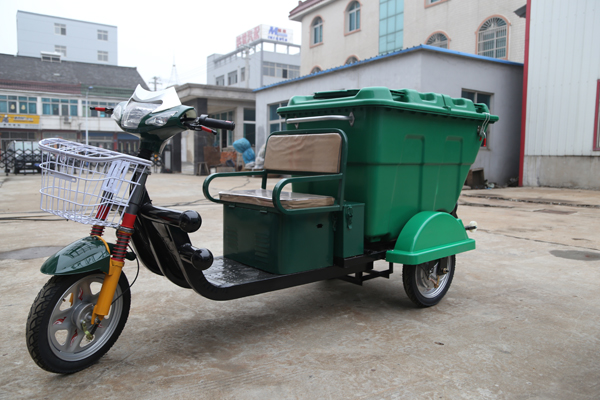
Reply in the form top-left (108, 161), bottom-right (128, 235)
top-left (277, 87), bottom-right (498, 242)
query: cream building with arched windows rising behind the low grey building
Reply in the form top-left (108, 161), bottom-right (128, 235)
top-left (289, 0), bottom-right (525, 75)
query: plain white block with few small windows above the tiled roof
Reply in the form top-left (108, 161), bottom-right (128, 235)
top-left (17, 11), bottom-right (118, 65)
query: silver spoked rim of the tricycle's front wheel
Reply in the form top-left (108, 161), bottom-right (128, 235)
top-left (48, 274), bottom-right (123, 361)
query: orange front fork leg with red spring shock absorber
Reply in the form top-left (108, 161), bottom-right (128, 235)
top-left (83, 169), bottom-right (148, 332)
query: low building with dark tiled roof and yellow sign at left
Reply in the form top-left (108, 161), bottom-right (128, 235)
top-left (0, 54), bottom-right (147, 156)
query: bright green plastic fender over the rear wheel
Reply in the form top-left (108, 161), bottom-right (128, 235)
top-left (386, 211), bottom-right (475, 265)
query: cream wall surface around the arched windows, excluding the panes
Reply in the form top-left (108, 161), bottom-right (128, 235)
top-left (292, 0), bottom-right (526, 75)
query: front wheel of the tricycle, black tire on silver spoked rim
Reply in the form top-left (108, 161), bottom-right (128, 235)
top-left (26, 271), bottom-right (131, 374)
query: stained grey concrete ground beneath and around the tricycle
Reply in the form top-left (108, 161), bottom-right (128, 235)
top-left (0, 174), bottom-right (600, 400)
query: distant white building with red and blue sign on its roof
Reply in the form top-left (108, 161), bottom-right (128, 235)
top-left (206, 25), bottom-right (300, 89)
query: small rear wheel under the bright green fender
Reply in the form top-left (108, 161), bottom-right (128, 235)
top-left (402, 256), bottom-right (456, 307)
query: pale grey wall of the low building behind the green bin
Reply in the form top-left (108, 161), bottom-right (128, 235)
top-left (256, 50), bottom-right (523, 184)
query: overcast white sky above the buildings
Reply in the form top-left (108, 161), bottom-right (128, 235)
top-left (0, 0), bottom-right (301, 88)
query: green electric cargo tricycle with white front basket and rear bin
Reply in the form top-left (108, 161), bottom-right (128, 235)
top-left (26, 87), bottom-right (498, 374)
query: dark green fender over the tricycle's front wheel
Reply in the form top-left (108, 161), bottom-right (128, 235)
top-left (41, 236), bottom-right (110, 275)
